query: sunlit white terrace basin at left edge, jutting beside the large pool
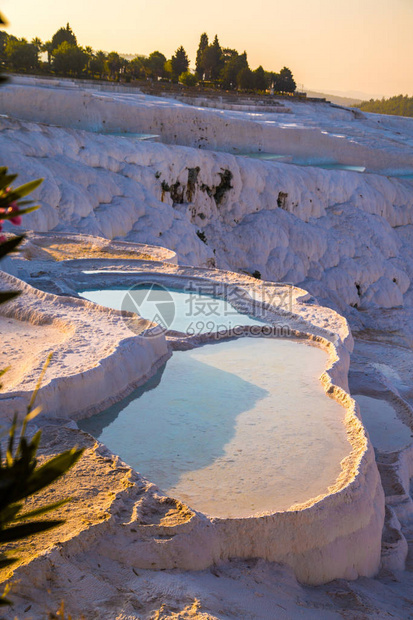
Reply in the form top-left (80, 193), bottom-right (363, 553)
top-left (0, 272), bottom-right (170, 421)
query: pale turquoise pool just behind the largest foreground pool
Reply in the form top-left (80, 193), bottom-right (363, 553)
top-left (79, 285), bottom-right (265, 335)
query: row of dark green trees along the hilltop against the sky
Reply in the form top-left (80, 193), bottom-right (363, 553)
top-left (0, 24), bottom-right (296, 93)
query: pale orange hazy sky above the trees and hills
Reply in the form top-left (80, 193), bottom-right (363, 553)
top-left (1, 0), bottom-right (413, 96)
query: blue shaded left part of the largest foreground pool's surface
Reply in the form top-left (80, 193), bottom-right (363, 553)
top-left (79, 352), bottom-right (269, 490)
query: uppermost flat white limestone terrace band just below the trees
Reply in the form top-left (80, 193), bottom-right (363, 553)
top-left (0, 76), bottom-right (413, 173)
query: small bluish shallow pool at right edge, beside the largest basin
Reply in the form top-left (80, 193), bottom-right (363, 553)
top-left (354, 394), bottom-right (413, 452)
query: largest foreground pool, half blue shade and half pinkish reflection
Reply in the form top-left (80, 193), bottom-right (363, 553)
top-left (79, 338), bottom-right (351, 518)
